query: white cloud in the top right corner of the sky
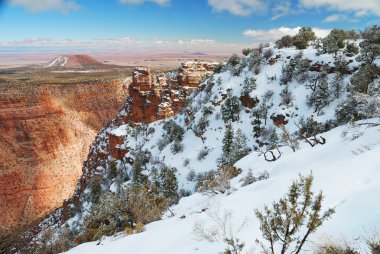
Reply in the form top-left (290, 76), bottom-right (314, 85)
top-left (299, 0), bottom-right (380, 17)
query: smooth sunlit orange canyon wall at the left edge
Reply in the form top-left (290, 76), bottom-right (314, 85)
top-left (0, 81), bottom-right (123, 236)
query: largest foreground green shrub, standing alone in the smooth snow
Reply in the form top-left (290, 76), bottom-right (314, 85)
top-left (255, 175), bottom-right (335, 254)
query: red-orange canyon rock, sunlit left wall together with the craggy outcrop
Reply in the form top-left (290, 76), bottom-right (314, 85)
top-left (0, 61), bottom-right (216, 248)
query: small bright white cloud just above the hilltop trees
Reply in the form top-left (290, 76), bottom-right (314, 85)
top-left (243, 26), bottom-right (331, 41)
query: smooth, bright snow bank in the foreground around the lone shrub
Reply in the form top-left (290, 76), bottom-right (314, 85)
top-left (67, 119), bottom-right (380, 254)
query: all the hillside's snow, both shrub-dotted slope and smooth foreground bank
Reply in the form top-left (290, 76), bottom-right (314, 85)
top-left (31, 41), bottom-right (380, 254)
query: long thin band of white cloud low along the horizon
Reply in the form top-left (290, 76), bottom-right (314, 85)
top-left (0, 37), bottom-right (253, 52)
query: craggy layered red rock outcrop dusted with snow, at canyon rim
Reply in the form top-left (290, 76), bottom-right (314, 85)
top-left (123, 62), bottom-right (215, 123)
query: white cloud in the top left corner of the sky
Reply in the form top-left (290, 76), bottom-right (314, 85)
top-left (8, 0), bottom-right (80, 13)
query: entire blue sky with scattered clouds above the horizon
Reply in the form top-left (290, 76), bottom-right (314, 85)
top-left (0, 0), bottom-right (380, 50)
